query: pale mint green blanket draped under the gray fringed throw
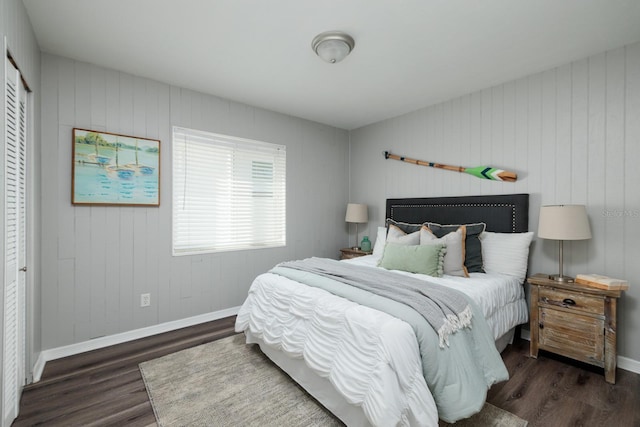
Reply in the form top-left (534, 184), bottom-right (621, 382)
top-left (271, 261), bottom-right (509, 423)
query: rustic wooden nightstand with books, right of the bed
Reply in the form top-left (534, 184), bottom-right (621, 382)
top-left (527, 274), bottom-right (621, 384)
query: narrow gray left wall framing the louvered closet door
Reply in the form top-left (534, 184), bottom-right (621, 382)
top-left (0, 0), bottom-right (41, 393)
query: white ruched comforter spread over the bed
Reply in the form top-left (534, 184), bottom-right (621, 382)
top-left (236, 257), bottom-right (527, 426)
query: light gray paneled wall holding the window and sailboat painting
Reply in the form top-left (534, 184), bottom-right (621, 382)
top-left (40, 54), bottom-right (349, 349)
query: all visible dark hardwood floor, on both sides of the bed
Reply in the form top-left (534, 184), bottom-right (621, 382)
top-left (13, 317), bottom-right (640, 427)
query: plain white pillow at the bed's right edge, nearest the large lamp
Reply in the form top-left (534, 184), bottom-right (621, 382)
top-left (479, 231), bottom-right (533, 282)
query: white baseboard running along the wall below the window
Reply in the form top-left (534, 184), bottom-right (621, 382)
top-left (33, 306), bottom-right (240, 383)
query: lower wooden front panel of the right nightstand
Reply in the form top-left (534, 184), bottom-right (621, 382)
top-left (538, 307), bottom-right (604, 367)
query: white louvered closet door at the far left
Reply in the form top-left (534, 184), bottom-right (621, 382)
top-left (2, 58), bottom-right (27, 426)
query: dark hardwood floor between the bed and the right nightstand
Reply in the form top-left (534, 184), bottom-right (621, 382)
top-left (487, 339), bottom-right (640, 427)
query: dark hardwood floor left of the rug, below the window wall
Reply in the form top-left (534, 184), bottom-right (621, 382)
top-left (12, 317), bottom-right (235, 427)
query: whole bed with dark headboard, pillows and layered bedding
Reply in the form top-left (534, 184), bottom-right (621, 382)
top-left (236, 194), bottom-right (532, 426)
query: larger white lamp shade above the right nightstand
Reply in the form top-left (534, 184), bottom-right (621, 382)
top-left (538, 205), bottom-right (591, 240)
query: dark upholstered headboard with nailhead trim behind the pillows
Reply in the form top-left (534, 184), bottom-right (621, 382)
top-left (387, 194), bottom-right (529, 233)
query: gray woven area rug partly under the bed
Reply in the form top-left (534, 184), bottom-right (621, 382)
top-left (140, 334), bottom-right (526, 427)
